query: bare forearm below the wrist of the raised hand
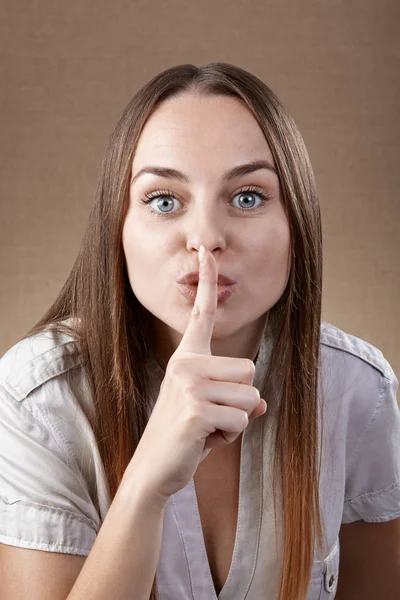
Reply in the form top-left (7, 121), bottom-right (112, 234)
top-left (67, 468), bottom-right (165, 600)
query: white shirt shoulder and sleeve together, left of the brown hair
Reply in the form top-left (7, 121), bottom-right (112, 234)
top-left (0, 322), bottom-right (110, 556)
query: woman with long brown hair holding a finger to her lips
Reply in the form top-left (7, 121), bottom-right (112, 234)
top-left (0, 63), bottom-right (400, 600)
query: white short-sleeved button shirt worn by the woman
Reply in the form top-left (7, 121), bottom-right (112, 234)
top-left (0, 321), bottom-right (400, 600)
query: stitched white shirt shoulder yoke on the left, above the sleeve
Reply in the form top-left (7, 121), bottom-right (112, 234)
top-left (0, 318), bottom-right (82, 402)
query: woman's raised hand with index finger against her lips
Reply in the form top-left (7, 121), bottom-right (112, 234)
top-left (130, 246), bottom-right (266, 502)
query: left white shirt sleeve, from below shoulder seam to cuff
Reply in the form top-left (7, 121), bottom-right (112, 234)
top-left (0, 385), bottom-right (99, 556)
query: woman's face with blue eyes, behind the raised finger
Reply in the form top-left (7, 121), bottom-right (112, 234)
top-left (123, 94), bottom-right (290, 356)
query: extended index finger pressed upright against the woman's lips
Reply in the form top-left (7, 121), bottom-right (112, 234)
top-left (176, 246), bottom-right (218, 354)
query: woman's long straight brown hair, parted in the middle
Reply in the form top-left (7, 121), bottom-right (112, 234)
top-left (25, 62), bottom-right (325, 600)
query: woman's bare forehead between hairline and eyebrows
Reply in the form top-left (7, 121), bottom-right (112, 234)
top-left (132, 94), bottom-right (274, 172)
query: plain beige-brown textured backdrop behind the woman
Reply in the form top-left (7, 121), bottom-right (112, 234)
top-left (0, 0), bottom-right (400, 384)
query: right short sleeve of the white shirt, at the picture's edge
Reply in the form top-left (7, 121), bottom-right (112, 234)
top-left (342, 359), bottom-right (400, 523)
